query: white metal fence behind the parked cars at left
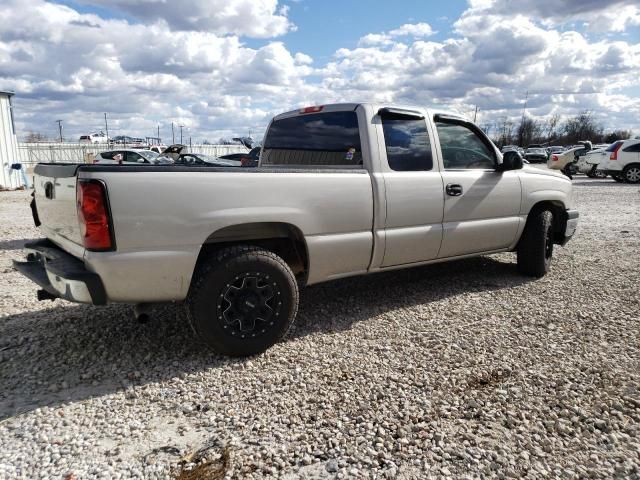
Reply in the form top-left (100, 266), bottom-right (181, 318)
top-left (15, 142), bottom-right (247, 165)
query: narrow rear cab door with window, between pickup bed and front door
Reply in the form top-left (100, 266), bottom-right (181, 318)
top-left (378, 108), bottom-right (443, 267)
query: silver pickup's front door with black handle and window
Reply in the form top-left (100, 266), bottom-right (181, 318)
top-left (435, 117), bottom-right (522, 258)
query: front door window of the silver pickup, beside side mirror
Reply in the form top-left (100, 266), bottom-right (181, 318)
top-left (436, 121), bottom-right (496, 170)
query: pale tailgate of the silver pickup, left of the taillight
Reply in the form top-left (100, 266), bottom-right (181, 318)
top-left (34, 163), bottom-right (84, 257)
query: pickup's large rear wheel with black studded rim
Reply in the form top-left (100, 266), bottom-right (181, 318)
top-left (185, 246), bottom-right (298, 357)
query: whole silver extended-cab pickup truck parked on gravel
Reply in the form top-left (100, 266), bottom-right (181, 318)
top-left (14, 104), bottom-right (578, 355)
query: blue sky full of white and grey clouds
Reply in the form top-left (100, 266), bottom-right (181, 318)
top-left (0, 0), bottom-right (640, 142)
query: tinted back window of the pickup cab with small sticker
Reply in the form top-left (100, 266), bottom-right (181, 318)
top-left (262, 111), bottom-right (363, 168)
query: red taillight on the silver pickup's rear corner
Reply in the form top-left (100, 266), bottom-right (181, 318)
top-left (77, 180), bottom-right (113, 251)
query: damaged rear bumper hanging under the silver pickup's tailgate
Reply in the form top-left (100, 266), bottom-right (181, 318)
top-left (13, 239), bottom-right (107, 305)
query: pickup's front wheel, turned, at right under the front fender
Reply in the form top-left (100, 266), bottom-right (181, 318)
top-left (517, 210), bottom-right (553, 278)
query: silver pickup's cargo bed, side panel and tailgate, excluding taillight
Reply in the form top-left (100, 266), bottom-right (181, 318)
top-left (35, 164), bottom-right (374, 302)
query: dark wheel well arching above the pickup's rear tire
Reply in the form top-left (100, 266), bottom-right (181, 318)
top-left (198, 222), bottom-right (309, 282)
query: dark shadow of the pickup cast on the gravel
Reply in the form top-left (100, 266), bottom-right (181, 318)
top-left (0, 257), bottom-right (530, 420)
